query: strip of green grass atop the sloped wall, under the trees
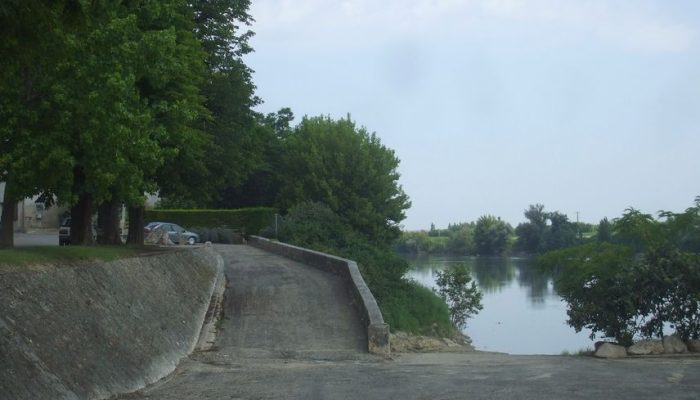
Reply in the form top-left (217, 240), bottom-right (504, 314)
top-left (0, 246), bottom-right (144, 266)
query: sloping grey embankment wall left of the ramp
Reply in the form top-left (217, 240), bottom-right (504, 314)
top-left (0, 248), bottom-right (223, 399)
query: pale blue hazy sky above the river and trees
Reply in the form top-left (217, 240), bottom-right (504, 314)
top-left (246, 0), bottom-right (700, 230)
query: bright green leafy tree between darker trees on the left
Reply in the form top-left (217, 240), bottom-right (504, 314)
top-left (56, 0), bottom-right (203, 243)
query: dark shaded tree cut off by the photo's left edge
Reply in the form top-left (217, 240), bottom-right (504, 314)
top-left (0, 0), bottom-right (80, 247)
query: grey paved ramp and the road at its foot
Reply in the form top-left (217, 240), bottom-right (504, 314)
top-left (123, 246), bottom-right (700, 400)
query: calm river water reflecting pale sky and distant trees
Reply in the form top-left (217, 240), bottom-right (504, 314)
top-left (408, 256), bottom-right (593, 354)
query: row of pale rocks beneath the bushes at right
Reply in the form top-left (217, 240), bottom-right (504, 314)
top-left (593, 336), bottom-right (700, 358)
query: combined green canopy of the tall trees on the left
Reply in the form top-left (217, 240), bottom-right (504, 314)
top-left (0, 0), bottom-right (266, 247)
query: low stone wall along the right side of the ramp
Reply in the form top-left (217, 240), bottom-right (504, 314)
top-left (248, 236), bottom-right (391, 356)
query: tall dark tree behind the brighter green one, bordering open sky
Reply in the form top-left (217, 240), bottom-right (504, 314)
top-left (158, 0), bottom-right (270, 207)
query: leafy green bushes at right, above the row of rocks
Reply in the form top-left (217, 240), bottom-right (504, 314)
top-left (539, 199), bottom-right (700, 344)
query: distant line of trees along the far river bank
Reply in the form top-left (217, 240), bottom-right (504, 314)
top-left (396, 204), bottom-right (592, 256)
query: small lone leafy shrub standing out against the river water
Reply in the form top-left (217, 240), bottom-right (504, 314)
top-left (435, 264), bottom-right (483, 328)
